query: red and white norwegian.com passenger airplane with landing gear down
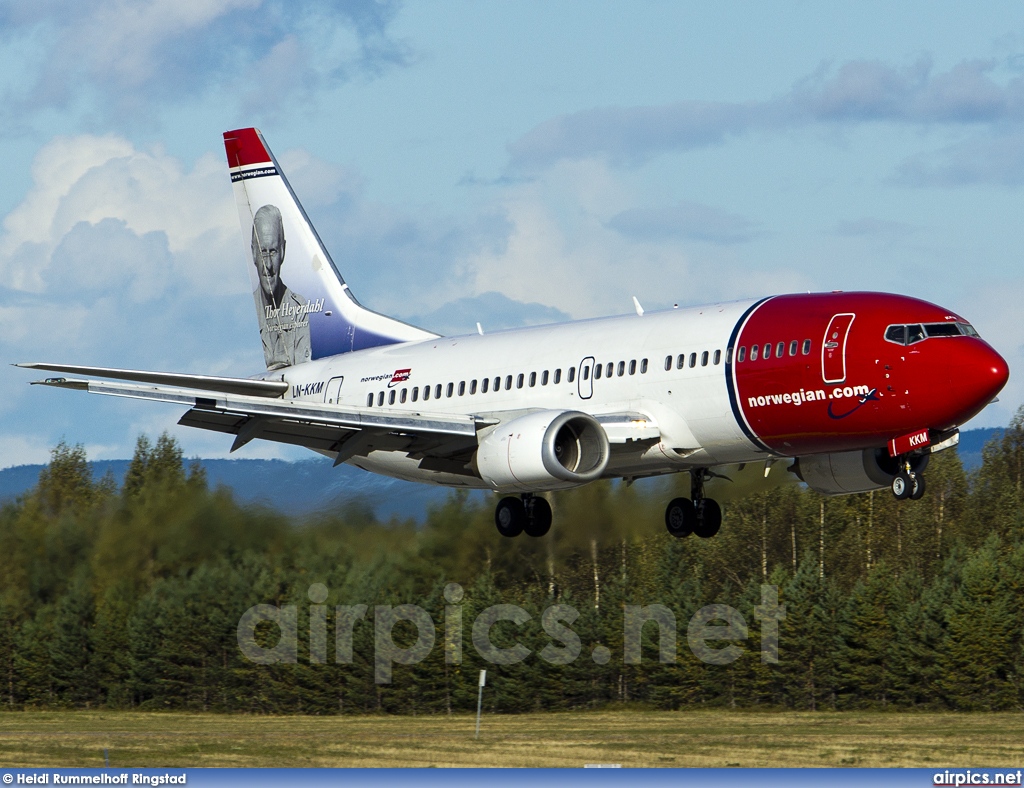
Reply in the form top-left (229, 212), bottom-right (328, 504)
top-left (20, 129), bottom-right (1009, 537)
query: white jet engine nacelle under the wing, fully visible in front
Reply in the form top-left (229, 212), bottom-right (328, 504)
top-left (476, 410), bottom-right (609, 492)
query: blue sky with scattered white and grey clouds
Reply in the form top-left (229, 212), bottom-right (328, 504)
top-left (0, 0), bottom-right (1024, 466)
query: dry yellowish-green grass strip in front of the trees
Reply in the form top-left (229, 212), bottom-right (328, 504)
top-left (0, 710), bottom-right (1024, 768)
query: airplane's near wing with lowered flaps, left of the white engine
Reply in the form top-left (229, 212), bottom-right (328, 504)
top-left (26, 374), bottom-right (485, 466)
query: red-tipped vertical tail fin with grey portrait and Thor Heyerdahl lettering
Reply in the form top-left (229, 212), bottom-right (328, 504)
top-left (224, 129), bottom-right (437, 369)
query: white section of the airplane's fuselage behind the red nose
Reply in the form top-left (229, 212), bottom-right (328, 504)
top-left (272, 302), bottom-right (767, 487)
